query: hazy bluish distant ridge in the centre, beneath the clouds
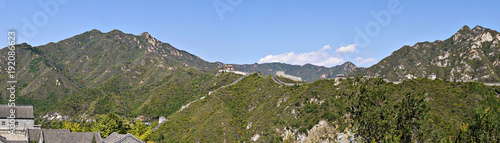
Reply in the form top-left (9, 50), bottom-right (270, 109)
top-left (233, 62), bottom-right (357, 82)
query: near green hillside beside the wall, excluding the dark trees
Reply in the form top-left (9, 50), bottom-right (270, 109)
top-left (150, 74), bottom-right (500, 142)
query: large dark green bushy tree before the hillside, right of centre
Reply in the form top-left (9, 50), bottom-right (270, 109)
top-left (349, 80), bottom-right (429, 142)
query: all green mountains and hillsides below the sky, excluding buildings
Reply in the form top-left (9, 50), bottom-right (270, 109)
top-left (0, 26), bottom-right (500, 142)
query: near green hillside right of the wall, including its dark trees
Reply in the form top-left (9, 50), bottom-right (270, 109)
top-left (150, 74), bottom-right (500, 142)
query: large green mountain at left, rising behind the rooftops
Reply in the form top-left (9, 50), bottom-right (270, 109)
top-left (0, 30), bottom-right (226, 117)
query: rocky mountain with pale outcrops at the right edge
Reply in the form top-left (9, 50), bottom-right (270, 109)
top-left (354, 26), bottom-right (500, 82)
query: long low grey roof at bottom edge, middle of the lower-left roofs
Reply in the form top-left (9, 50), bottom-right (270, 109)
top-left (42, 131), bottom-right (102, 143)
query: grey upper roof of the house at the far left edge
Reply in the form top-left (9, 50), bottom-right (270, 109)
top-left (0, 104), bottom-right (35, 119)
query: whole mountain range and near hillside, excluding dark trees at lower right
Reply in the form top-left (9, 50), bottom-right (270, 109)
top-left (0, 26), bottom-right (500, 142)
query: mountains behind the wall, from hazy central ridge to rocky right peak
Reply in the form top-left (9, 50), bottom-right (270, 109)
top-left (233, 25), bottom-right (500, 82)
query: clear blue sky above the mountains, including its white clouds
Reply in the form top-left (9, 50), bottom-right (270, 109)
top-left (0, 0), bottom-right (500, 67)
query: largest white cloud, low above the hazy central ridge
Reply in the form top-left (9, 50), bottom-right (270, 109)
top-left (258, 45), bottom-right (344, 67)
